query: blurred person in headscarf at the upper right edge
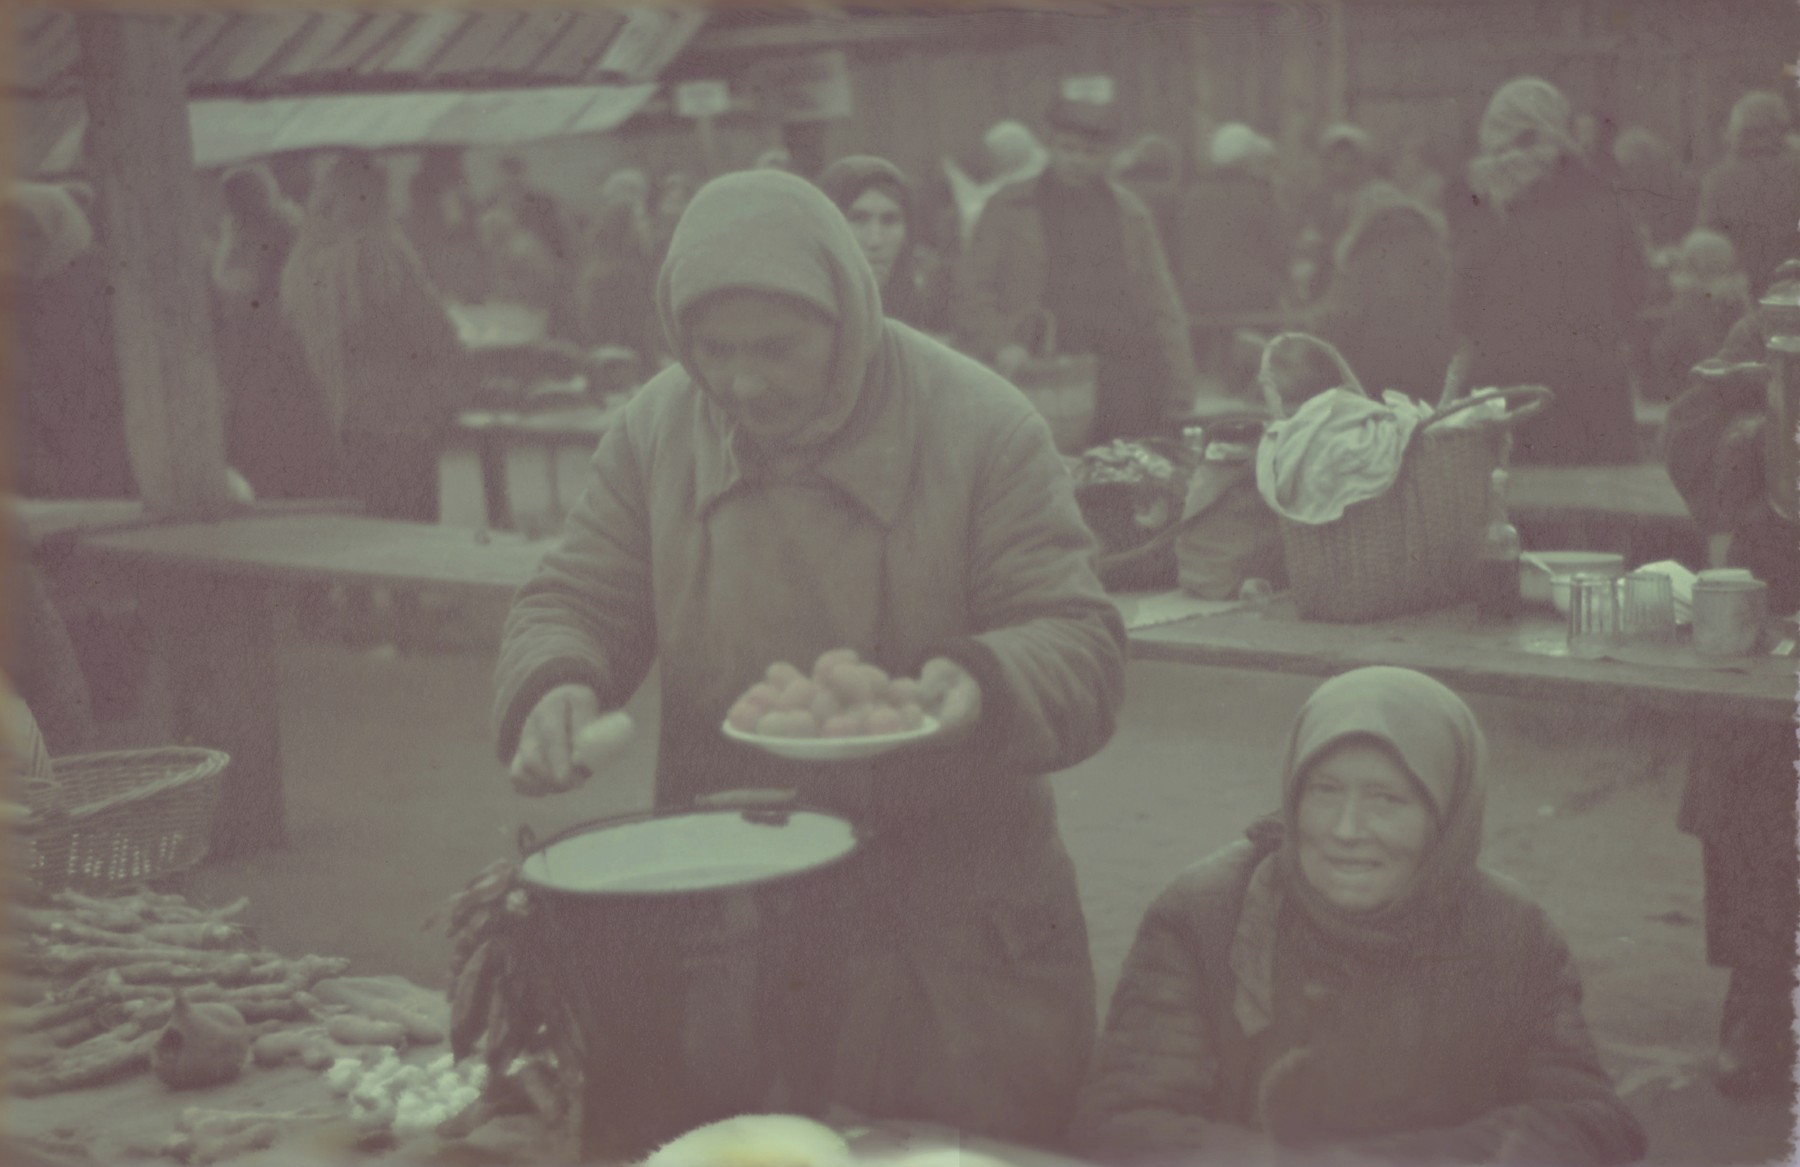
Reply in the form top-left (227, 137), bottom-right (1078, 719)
top-left (1696, 92), bottom-right (1800, 295)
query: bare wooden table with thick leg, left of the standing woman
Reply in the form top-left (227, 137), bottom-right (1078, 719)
top-left (68, 513), bottom-right (551, 855)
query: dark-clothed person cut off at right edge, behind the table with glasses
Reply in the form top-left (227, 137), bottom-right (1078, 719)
top-left (1663, 259), bottom-right (1800, 1102)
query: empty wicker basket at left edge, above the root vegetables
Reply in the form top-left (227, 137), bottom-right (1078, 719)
top-left (18, 747), bottom-right (230, 891)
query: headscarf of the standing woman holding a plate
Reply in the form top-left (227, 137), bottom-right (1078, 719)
top-left (657, 171), bottom-right (886, 448)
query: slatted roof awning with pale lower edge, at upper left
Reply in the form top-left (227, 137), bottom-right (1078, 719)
top-left (21, 7), bottom-right (706, 175)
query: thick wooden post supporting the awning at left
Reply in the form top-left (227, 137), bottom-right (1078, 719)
top-left (76, 13), bottom-right (230, 519)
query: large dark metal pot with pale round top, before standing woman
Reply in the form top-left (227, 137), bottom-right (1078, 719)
top-left (518, 803), bottom-right (860, 1162)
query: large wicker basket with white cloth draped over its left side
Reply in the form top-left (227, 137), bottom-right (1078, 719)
top-left (1265, 337), bottom-right (1550, 623)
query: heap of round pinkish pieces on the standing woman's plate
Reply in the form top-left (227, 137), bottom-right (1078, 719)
top-left (729, 648), bottom-right (925, 738)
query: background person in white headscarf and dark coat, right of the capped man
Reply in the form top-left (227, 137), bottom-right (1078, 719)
top-left (1170, 122), bottom-right (1289, 389)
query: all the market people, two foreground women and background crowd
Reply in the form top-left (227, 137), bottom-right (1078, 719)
top-left (13, 66), bottom-right (1800, 1163)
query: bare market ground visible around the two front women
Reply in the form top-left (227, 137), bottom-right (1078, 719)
top-left (105, 611), bottom-right (1791, 1167)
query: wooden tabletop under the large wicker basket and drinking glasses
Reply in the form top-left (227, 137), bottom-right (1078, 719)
top-left (1130, 602), bottom-right (1795, 724)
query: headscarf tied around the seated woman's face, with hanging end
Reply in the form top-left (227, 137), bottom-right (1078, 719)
top-left (1229, 668), bottom-right (1487, 1034)
